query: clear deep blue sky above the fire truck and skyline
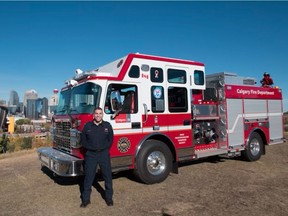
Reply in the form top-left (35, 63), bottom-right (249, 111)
top-left (0, 1), bottom-right (288, 111)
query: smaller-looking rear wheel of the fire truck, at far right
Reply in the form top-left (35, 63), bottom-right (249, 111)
top-left (243, 132), bottom-right (263, 161)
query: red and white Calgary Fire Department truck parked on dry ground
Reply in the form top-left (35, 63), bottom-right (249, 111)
top-left (37, 53), bottom-right (284, 184)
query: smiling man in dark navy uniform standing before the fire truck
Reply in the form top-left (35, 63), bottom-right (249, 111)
top-left (80, 107), bottom-right (114, 208)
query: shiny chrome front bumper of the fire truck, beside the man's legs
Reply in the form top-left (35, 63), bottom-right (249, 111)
top-left (37, 147), bottom-right (84, 176)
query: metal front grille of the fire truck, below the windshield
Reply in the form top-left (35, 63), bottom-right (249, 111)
top-left (54, 121), bottom-right (71, 153)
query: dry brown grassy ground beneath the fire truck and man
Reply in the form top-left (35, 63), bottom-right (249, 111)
top-left (0, 143), bottom-right (288, 216)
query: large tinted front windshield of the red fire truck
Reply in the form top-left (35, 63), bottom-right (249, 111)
top-left (56, 83), bottom-right (101, 115)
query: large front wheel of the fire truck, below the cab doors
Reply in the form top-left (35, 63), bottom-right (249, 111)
top-left (134, 140), bottom-right (172, 184)
